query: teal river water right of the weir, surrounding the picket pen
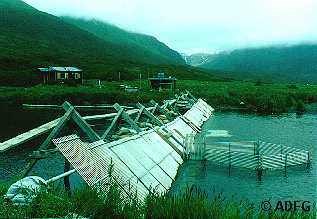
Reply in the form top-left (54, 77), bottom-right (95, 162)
top-left (172, 113), bottom-right (317, 208)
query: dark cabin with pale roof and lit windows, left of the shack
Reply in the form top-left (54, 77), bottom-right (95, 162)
top-left (38, 67), bottom-right (83, 84)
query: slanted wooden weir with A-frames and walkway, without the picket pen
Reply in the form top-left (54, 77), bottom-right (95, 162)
top-left (0, 92), bottom-right (213, 201)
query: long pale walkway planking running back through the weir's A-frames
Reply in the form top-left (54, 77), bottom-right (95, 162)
top-left (0, 107), bottom-right (153, 153)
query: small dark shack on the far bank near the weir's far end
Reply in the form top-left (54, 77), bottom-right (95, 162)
top-left (149, 72), bottom-right (176, 90)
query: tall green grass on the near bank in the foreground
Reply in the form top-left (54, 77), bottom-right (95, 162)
top-left (0, 183), bottom-right (316, 219)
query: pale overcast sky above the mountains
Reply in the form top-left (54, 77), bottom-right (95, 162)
top-left (24, 0), bottom-right (317, 54)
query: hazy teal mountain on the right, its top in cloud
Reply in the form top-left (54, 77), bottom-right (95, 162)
top-left (200, 44), bottom-right (317, 83)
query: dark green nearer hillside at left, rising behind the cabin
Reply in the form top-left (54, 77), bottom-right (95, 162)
top-left (0, 0), bottom-right (190, 85)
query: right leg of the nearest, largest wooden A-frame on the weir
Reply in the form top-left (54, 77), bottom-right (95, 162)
top-left (63, 101), bottom-right (101, 141)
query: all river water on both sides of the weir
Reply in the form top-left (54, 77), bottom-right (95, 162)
top-left (0, 109), bottom-right (317, 208)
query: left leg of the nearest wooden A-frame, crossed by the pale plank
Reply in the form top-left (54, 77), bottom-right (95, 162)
top-left (21, 106), bottom-right (74, 178)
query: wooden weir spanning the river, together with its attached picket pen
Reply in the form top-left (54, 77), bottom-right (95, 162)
top-left (0, 91), bottom-right (309, 201)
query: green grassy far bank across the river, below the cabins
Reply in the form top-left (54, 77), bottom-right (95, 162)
top-left (0, 80), bottom-right (317, 113)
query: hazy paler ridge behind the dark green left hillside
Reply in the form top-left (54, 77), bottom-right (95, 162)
top-left (62, 17), bottom-right (185, 64)
